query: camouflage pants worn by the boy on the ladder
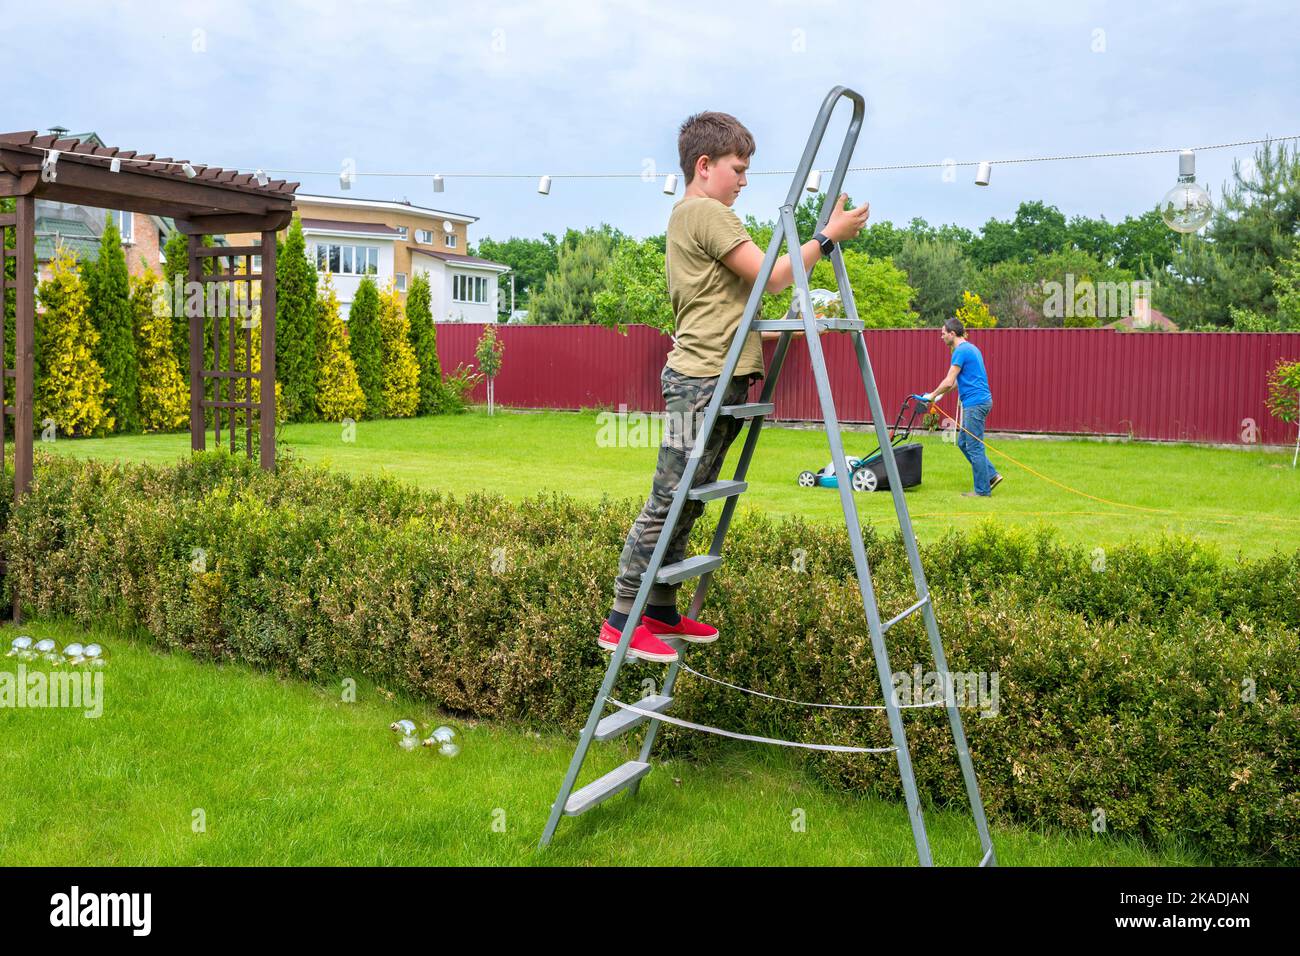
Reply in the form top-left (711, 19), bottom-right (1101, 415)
top-left (614, 365), bottom-right (759, 614)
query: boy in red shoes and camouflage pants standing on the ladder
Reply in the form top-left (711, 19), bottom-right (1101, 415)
top-left (597, 112), bottom-right (868, 662)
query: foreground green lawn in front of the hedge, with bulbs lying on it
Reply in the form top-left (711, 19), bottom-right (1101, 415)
top-left (0, 622), bottom-right (1208, 866)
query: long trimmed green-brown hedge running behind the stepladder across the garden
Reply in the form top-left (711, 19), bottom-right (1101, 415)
top-left (0, 453), bottom-right (1300, 864)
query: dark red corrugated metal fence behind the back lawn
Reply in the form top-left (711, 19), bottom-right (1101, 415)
top-left (438, 323), bottom-right (1300, 445)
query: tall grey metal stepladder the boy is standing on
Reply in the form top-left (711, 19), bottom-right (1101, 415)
top-left (540, 86), bottom-right (997, 866)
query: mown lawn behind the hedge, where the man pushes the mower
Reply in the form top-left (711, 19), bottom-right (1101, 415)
top-left (30, 408), bottom-right (1300, 557)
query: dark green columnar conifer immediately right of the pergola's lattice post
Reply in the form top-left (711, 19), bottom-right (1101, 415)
top-left (276, 222), bottom-right (319, 420)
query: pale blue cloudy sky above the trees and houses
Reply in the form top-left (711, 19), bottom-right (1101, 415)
top-left (0, 0), bottom-right (1300, 247)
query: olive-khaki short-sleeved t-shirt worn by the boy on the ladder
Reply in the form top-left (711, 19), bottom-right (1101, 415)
top-left (664, 196), bottom-right (766, 378)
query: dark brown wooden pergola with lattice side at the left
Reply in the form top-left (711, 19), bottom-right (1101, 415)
top-left (0, 130), bottom-right (298, 481)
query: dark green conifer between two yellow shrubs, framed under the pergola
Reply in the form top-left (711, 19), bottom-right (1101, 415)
top-left (83, 213), bottom-right (140, 432)
